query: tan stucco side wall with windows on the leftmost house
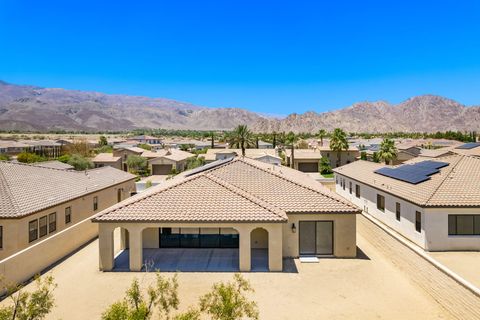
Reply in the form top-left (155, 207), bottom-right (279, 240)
top-left (0, 180), bottom-right (135, 262)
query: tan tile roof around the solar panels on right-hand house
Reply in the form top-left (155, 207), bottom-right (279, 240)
top-left (333, 155), bottom-right (480, 207)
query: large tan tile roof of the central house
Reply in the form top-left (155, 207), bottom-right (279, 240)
top-left (93, 157), bottom-right (358, 222)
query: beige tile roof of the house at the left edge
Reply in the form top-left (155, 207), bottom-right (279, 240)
top-left (0, 161), bottom-right (135, 218)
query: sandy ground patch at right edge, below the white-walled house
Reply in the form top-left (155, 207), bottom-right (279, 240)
top-left (428, 251), bottom-right (480, 288)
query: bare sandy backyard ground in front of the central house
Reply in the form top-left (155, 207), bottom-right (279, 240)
top-left (3, 236), bottom-right (450, 319)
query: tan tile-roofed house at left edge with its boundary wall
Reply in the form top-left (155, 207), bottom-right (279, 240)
top-left (0, 161), bottom-right (135, 283)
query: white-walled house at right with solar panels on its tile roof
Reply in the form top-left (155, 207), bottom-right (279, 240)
top-left (334, 155), bottom-right (480, 251)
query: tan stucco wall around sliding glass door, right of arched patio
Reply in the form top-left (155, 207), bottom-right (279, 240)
top-left (283, 214), bottom-right (357, 258)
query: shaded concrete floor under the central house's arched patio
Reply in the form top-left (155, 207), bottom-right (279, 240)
top-left (113, 248), bottom-right (268, 272)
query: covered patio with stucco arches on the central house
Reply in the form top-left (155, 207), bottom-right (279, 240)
top-left (99, 223), bottom-right (283, 272)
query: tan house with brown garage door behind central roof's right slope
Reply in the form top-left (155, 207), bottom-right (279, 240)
top-left (285, 146), bottom-right (360, 172)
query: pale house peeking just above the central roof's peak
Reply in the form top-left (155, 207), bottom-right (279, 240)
top-left (199, 149), bottom-right (282, 164)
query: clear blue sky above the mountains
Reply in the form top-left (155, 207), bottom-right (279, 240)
top-left (0, 0), bottom-right (480, 114)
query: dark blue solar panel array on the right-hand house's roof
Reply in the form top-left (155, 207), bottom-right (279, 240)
top-left (375, 160), bottom-right (448, 184)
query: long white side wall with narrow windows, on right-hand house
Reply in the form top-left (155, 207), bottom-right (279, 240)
top-left (335, 173), bottom-right (427, 249)
